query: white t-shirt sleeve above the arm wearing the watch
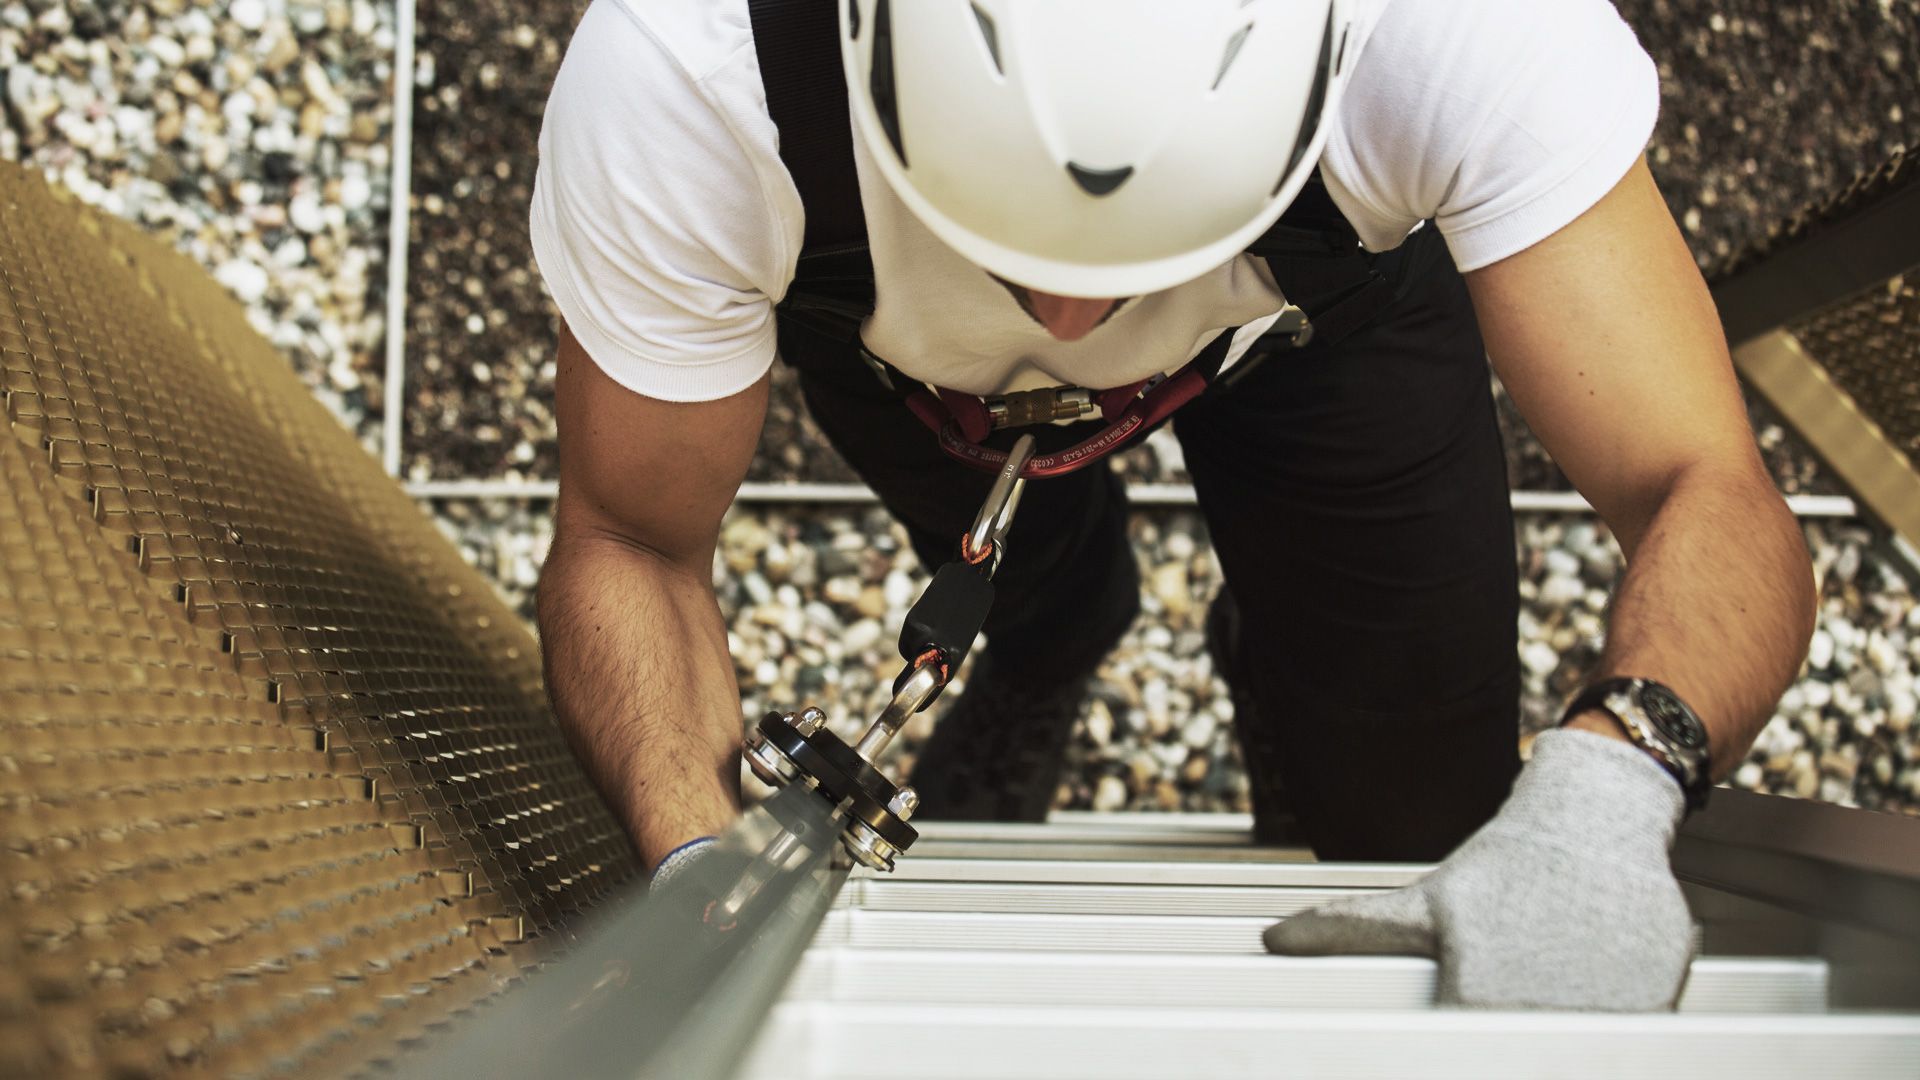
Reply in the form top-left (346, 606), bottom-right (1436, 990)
top-left (1325, 0), bottom-right (1659, 271)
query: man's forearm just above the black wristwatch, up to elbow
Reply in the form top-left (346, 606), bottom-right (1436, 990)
top-left (1576, 469), bottom-right (1814, 778)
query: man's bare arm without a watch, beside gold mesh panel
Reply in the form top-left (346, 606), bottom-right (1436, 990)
top-left (540, 327), bottom-right (768, 867)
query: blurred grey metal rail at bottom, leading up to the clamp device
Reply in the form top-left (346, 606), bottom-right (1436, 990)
top-left (408, 788), bottom-right (845, 1080)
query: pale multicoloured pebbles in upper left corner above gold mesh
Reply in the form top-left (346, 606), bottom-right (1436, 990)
top-left (0, 0), bottom-right (394, 448)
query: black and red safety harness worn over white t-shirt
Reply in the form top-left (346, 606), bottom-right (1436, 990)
top-left (747, 0), bottom-right (1404, 479)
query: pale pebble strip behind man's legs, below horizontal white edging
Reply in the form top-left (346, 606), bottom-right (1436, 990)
top-left (436, 502), bottom-right (1920, 813)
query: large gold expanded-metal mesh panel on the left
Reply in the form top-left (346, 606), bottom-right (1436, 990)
top-left (0, 165), bottom-right (636, 1076)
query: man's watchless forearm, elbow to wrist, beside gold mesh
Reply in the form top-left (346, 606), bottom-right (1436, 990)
top-left (540, 532), bottom-right (739, 867)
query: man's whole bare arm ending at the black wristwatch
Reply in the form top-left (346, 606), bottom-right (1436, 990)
top-left (1467, 163), bottom-right (1814, 764)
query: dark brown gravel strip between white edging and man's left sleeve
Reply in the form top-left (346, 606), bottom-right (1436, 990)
top-left (401, 0), bottom-right (564, 479)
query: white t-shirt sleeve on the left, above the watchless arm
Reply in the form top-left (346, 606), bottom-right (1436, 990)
top-left (528, 0), bottom-right (803, 402)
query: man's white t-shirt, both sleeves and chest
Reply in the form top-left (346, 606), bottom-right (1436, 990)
top-left (532, 0), bottom-right (1659, 402)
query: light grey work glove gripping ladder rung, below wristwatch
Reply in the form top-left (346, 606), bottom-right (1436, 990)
top-left (1265, 730), bottom-right (1693, 1011)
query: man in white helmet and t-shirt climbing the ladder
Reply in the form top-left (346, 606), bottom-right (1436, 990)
top-left (532, 0), bottom-right (1812, 1009)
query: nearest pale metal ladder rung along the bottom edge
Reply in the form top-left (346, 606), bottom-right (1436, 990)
top-left (747, 1003), bottom-right (1920, 1080)
